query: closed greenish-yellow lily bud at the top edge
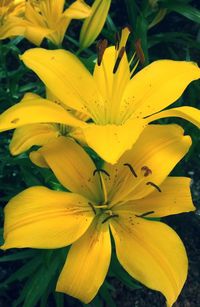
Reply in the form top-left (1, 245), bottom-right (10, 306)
top-left (80, 0), bottom-right (111, 49)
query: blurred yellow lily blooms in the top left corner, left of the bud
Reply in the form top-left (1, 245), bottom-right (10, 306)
top-left (0, 0), bottom-right (91, 46)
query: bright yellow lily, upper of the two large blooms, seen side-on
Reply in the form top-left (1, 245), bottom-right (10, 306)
top-left (0, 29), bottom-right (200, 164)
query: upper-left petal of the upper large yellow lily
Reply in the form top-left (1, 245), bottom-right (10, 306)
top-left (21, 48), bottom-right (104, 118)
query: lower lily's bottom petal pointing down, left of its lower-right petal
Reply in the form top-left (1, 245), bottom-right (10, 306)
top-left (56, 220), bottom-right (111, 304)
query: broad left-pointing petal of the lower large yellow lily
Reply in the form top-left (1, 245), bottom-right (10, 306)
top-left (1, 187), bottom-right (94, 249)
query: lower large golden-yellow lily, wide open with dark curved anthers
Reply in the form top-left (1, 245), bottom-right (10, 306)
top-left (1, 125), bottom-right (194, 306)
